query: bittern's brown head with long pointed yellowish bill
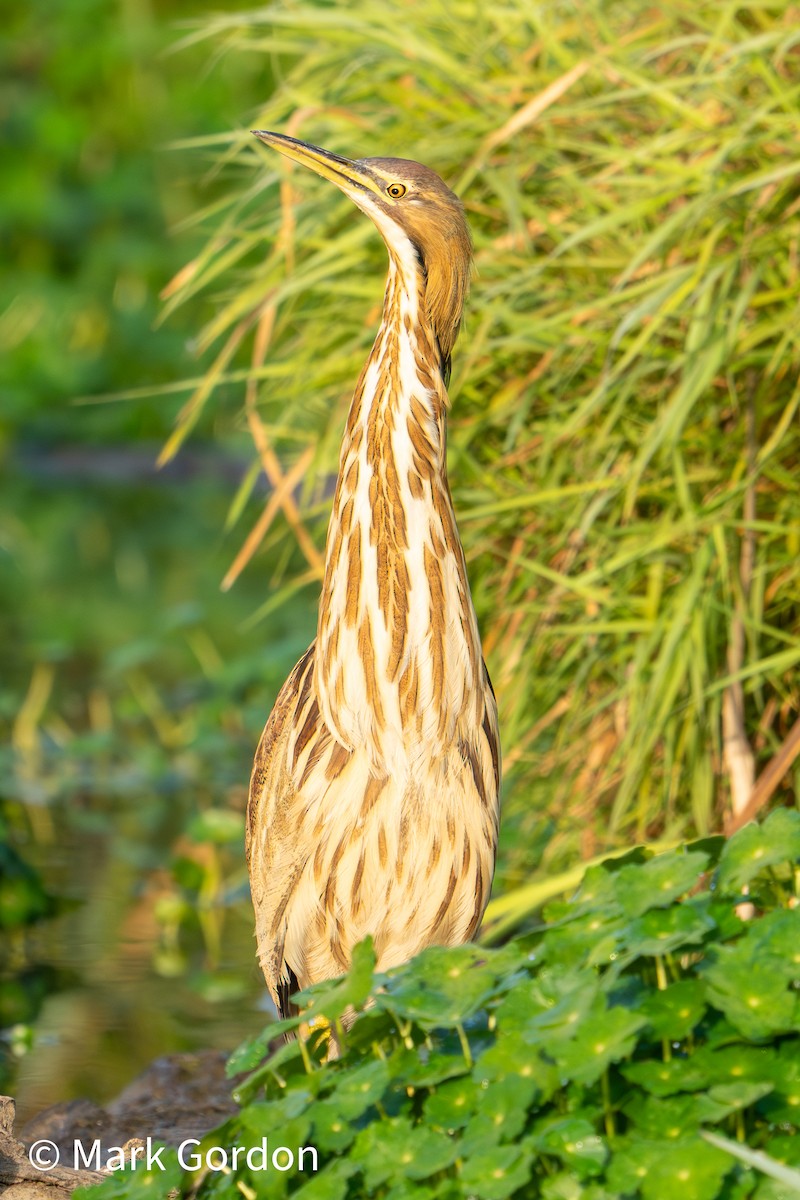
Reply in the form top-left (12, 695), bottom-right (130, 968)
top-left (253, 130), bottom-right (473, 373)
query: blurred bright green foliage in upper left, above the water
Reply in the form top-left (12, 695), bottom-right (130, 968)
top-left (0, 0), bottom-right (269, 446)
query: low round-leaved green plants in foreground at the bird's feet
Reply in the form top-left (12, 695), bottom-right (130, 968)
top-left (79, 811), bottom-right (800, 1200)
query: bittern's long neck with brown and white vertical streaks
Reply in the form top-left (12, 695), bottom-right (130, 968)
top-left (315, 252), bottom-right (482, 766)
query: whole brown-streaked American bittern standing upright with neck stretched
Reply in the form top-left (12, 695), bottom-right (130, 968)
top-left (247, 131), bottom-right (500, 1015)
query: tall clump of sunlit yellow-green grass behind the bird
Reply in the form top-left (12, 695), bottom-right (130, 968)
top-left (166, 0), bottom-right (800, 887)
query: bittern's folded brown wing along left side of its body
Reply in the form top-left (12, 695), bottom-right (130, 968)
top-left (245, 642), bottom-right (349, 1014)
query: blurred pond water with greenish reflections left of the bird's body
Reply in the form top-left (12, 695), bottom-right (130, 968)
top-left (0, 470), bottom-right (317, 1121)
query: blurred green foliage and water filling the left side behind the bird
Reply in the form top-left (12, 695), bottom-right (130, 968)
top-left (0, 0), bottom-right (313, 1117)
